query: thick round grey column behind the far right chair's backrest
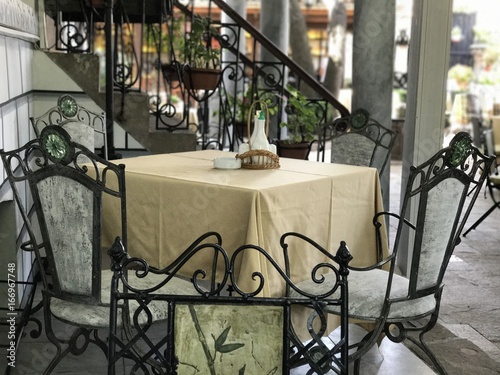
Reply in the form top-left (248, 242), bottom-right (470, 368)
top-left (351, 0), bottom-right (396, 209)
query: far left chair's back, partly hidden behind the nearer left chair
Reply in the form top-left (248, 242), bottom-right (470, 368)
top-left (30, 94), bottom-right (108, 160)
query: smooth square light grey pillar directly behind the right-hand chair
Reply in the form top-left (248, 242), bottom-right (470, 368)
top-left (398, 0), bottom-right (453, 274)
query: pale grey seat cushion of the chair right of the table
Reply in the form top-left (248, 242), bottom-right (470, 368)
top-left (290, 269), bottom-right (436, 321)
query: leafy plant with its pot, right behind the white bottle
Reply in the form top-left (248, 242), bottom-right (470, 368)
top-left (275, 85), bottom-right (321, 159)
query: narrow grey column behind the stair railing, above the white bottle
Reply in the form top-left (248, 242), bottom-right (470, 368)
top-left (260, 0), bottom-right (290, 139)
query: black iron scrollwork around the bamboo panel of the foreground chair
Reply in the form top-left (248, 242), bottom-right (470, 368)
top-left (108, 232), bottom-right (351, 374)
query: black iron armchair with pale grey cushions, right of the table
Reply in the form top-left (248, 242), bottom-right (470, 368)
top-left (290, 132), bottom-right (493, 374)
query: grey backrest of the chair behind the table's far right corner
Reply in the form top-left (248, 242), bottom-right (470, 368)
top-left (324, 109), bottom-right (396, 173)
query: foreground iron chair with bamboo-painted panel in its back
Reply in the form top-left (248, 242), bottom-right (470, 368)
top-left (108, 239), bottom-right (352, 375)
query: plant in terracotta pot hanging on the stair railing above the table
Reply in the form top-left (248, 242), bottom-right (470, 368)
top-left (183, 16), bottom-right (221, 90)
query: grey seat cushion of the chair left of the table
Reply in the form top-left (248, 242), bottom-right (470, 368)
top-left (50, 270), bottom-right (199, 328)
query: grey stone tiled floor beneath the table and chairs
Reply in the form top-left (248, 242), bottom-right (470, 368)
top-left (0, 162), bottom-right (500, 375)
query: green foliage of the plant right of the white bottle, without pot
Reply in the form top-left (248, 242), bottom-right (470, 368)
top-left (280, 85), bottom-right (321, 143)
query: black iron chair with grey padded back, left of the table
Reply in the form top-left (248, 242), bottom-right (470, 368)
top-left (0, 125), bottom-right (219, 374)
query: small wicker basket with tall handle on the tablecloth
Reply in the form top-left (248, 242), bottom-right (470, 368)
top-left (236, 100), bottom-right (280, 169)
